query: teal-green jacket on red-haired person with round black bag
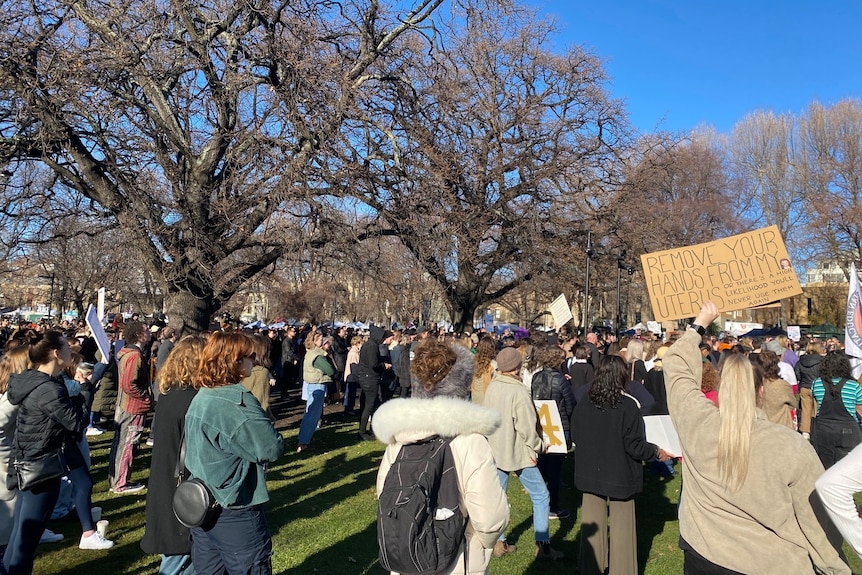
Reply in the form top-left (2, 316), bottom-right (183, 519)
top-left (186, 384), bottom-right (283, 508)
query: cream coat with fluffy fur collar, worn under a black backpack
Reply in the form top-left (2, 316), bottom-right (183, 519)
top-left (374, 397), bottom-right (509, 575)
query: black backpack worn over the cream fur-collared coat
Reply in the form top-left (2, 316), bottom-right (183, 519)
top-left (377, 436), bottom-right (467, 575)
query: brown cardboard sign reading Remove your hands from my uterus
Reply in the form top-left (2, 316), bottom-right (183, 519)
top-left (641, 226), bottom-right (802, 321)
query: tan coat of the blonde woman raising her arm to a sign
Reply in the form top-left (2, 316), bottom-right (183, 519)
top-left (664, 329), bottom-right (850, 575)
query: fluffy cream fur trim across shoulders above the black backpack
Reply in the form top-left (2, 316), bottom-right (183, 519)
top-left (372, 397), bottom-right (502, 445)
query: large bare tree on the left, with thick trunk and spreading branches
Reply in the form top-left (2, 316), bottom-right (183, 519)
top-left (0, 0), bottom-right (452, 331)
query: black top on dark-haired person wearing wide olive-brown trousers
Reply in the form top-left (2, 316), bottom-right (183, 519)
top-left (572, 396), bottom-right (658, 499)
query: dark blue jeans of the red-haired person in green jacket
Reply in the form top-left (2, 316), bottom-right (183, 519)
top-left (192, 505), bottom-right (272, 575)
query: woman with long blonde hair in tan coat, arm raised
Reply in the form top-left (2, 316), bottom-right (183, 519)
top-left (663, 302), bottom-right (850, 575)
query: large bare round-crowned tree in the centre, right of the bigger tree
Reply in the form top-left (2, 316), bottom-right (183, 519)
top-left (344, 5), bottom-right (627, 329)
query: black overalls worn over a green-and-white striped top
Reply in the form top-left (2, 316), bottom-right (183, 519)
top-left (811, 379), bottom-right (862, 469)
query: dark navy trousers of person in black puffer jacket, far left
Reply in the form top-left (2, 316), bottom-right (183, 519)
top-left (3, 477), bottom-right (60, 575)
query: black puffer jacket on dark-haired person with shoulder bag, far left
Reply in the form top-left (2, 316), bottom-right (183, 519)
top-left (8, 369), bottom-right (89, 461)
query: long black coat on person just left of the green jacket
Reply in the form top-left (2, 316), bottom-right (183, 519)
top-left (141, 387), bottom-right (197, 555)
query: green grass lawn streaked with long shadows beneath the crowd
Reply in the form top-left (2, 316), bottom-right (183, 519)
top-left (34, 416), bottom-right (862, 575)
